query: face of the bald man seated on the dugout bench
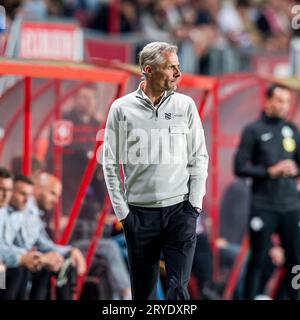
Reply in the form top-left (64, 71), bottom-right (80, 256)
top-left (36, 183), bottom-right (62, 212)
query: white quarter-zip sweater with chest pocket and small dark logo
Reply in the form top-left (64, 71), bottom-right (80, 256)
top-left (102, 87), bottom-right (208, 220)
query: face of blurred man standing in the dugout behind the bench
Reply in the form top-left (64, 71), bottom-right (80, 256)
top-left (74, 88), bottom-right (96, 116)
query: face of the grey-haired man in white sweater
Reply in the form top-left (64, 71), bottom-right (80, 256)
top-left (148, 52), bottom-right (181, 92)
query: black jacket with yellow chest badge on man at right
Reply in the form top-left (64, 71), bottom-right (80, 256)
top-left (234, 113), bottom-right (300, 211)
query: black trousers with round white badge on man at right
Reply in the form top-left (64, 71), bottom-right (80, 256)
top-left (245, 207), bottom-right (300, 300)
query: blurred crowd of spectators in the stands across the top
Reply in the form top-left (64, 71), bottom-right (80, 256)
top-left (1, 0), bottom-right (297, 57)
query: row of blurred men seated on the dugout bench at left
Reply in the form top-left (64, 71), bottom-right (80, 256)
top-left (0, 167), bottom-right (131, 300)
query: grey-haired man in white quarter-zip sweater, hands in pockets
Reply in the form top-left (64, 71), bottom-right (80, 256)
top-left (103, 42), bottom-right (208, 300)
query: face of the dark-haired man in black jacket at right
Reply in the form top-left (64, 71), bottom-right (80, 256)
top-left (266, 88), bottom-right (291, 119)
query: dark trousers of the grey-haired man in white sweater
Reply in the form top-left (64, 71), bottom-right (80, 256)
top-left (124, 201), bottom-right (198, 300)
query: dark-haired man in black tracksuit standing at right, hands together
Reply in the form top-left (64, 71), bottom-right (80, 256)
top-left (235, 85), bottom-right (300, 299)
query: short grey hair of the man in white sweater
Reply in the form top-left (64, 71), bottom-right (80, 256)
top-left (139, 42), bottom-right (178, 75)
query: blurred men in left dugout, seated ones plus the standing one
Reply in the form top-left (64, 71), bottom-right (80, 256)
top-left (0, 86), bottom-right (131, 300)
